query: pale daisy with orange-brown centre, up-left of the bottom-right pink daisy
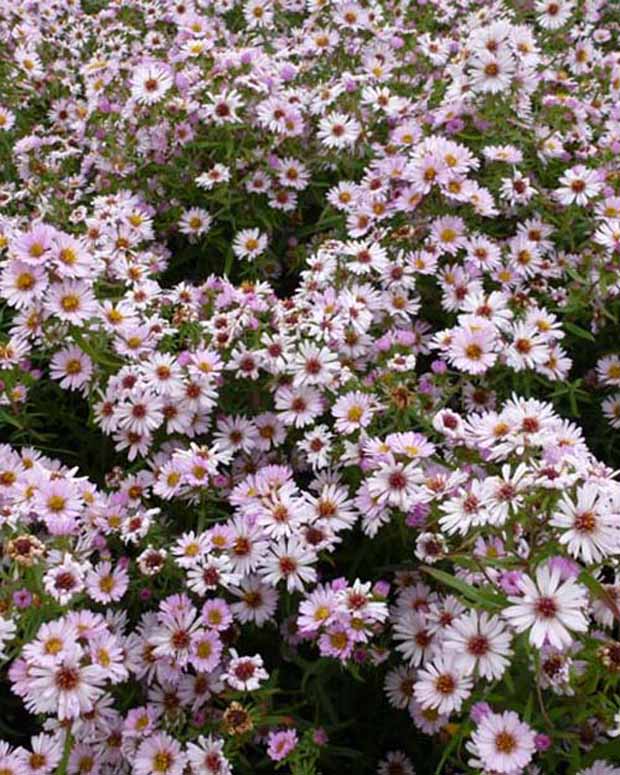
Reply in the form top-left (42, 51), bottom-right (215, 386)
top-left (413, 656), bottom-right (473, 714)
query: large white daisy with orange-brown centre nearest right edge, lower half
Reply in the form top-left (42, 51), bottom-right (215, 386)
top-left (549, 484), bottom-right (620, 565)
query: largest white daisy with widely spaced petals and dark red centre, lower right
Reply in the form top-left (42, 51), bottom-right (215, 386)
top-left (503, 565), bottom-right (588, 649)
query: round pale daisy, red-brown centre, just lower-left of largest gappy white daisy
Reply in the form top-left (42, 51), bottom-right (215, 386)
top-left (443, 611), bottom-right (512, 681)
